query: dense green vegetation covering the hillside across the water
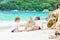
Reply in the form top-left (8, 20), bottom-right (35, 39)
top-left (0, 0), bottom-right (60, 11)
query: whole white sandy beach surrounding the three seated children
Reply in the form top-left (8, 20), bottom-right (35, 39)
top-left (0, 21), bottom-right (54, 40)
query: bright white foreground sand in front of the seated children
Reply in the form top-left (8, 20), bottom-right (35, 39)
top-left (0, 30), bottom-right (53, 40)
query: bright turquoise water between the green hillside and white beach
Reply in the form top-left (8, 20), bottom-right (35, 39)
top-left (0, 11), bottom-right (48, 21)
